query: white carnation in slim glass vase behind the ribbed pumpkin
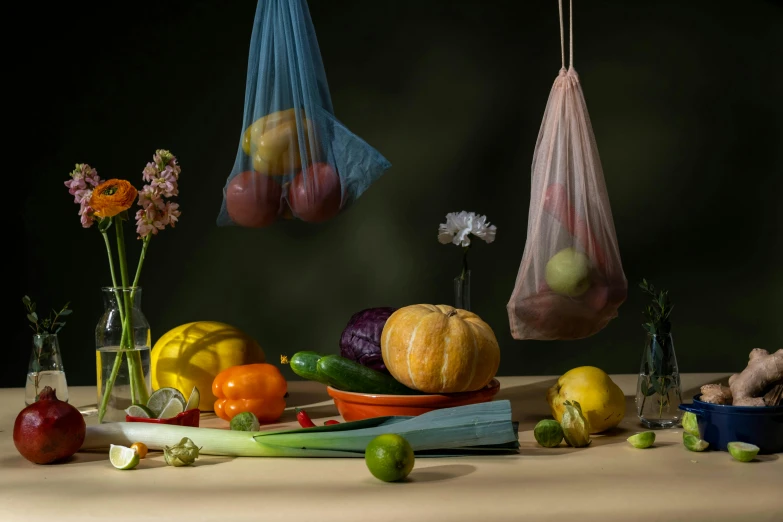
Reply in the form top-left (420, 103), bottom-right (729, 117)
top-left (438, 210), bottom-right (497, 311)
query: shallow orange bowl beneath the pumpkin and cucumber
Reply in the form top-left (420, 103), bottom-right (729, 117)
top-left (326, 379), bottom-right (500, 422)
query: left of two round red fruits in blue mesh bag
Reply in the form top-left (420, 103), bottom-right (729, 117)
top-left (226, 170), bottom-right (283, 228)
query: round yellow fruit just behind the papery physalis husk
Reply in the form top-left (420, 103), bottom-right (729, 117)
top-left (546, 366), bottom-right (625, 433)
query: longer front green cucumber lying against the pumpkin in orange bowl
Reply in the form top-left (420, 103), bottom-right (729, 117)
top-left (316, 355), bottom-right (420, 395)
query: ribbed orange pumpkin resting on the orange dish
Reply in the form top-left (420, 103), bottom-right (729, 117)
top-left (381, 304), bottom-right (500, 393)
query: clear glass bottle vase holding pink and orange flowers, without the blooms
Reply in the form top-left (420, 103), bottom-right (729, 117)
top-left (95, 287), bottom-right (152, 422)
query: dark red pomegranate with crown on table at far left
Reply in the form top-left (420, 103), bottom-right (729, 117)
top-left (14, 386), bottom-right (87, 464)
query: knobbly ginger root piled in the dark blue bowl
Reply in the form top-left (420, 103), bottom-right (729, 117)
top-left (701, 348), bottom-right (783, 406)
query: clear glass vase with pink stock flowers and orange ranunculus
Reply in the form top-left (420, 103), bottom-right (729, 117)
top-left (65, 149), bottom-right (180, 422)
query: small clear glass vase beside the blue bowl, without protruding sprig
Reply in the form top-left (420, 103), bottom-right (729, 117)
top-left (636, 334), bottom-right (682, 429)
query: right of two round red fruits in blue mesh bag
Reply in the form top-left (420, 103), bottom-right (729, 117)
top-left (288, 163), bottom-right (342, 223)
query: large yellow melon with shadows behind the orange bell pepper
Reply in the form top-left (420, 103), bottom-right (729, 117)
top-left (150, 321), bottom-right (266, 411)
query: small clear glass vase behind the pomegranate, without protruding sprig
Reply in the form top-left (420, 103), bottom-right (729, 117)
top-left (24, 333), bottom-right (68, 406)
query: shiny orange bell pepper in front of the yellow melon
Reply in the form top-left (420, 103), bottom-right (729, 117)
top-left (212, 363), bottom-right (288, 423)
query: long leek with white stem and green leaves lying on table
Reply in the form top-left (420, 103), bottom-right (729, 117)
top-left (81, 400), bottom-right (519, 457)
